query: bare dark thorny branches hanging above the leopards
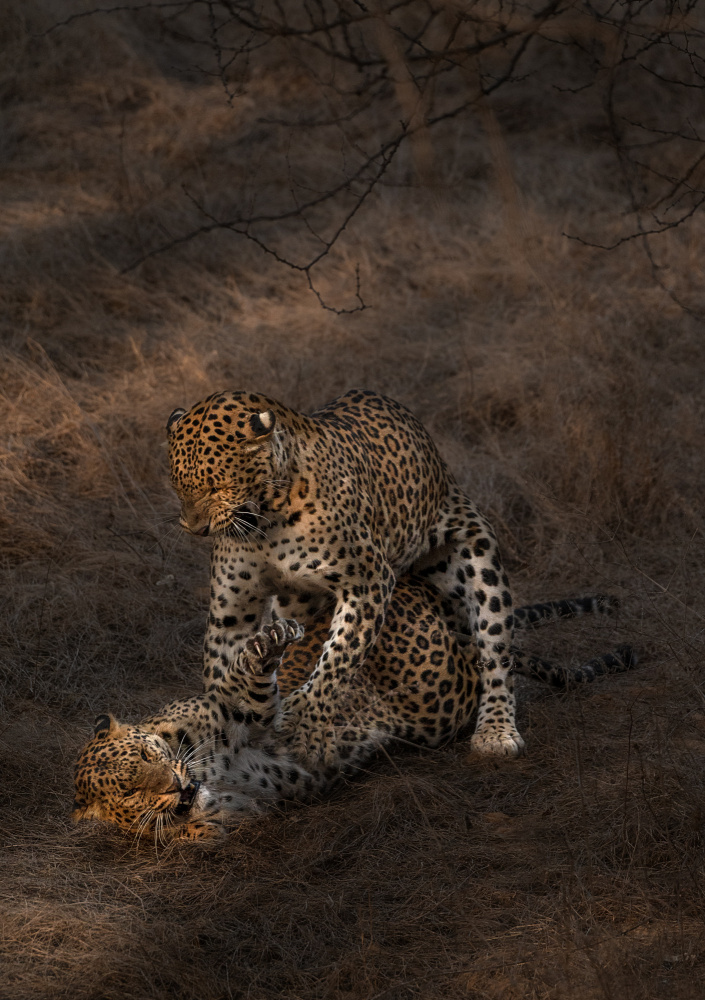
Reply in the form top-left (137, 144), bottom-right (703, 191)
top-left (44, 0), bottom-right (705, 310)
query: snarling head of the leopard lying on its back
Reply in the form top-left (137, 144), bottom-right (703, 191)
top-left (71, 715), bottom-right (214, 836)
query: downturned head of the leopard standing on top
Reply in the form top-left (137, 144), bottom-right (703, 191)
top-left (166, 391), bottom-right (279, 538)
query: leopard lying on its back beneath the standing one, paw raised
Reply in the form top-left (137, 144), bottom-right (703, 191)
top-left (72, 579), bottom-right (635, 842)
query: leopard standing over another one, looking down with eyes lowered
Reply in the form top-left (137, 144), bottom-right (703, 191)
top-left (167, 389), bottom-right (524, 761)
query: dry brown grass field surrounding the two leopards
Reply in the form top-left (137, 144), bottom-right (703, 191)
top-left (0, 0), bottom-right (705, 1000)
